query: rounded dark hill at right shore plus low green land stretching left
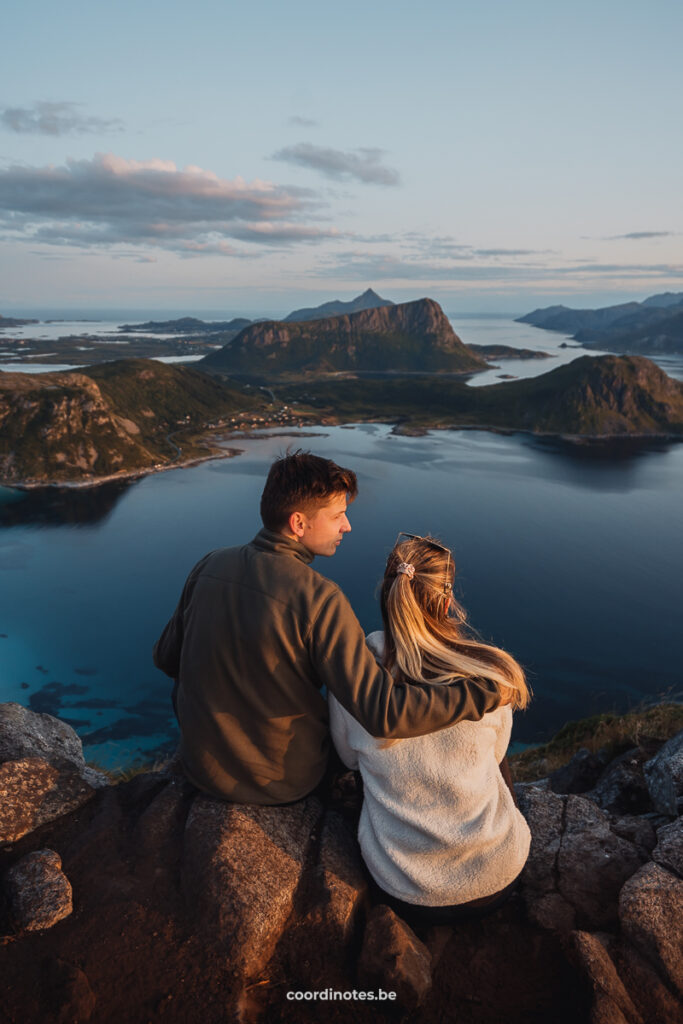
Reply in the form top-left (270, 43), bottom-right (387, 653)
top-left (279, 355), bottom-right (683, 438)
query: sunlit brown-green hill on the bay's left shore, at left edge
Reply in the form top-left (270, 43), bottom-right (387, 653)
top-left (0, 359), bottom-right (263, 485)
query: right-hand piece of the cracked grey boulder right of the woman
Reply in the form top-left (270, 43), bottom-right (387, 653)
top-left (557, 796), bottom-right (642, 929)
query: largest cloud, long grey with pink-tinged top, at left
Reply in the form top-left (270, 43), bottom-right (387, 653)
top-left (0, 154), bottom-right (339, 255)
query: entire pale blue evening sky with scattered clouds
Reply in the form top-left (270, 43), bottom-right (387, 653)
top-left (0, 0), bottom-right (683, 316)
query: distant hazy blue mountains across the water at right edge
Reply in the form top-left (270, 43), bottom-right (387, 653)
top-left (518, 292), bottom-right (683, 355)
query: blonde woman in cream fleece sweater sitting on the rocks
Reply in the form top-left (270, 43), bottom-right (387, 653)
top-left (329, 534), bottom-right (530, 924)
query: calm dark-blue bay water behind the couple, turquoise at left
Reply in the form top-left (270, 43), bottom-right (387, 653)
top-left (0, 425), bottom-right (683, 766)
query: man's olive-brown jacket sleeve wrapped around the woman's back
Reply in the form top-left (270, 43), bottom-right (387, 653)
top-left (307, 587), bottom-right (501, 739)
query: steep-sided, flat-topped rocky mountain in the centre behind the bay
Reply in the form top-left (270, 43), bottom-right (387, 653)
top-left (198, 299), bottom-right (486, 378)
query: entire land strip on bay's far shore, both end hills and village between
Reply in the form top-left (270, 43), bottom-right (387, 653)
top-left (0, 355), bottom-right (683, 487)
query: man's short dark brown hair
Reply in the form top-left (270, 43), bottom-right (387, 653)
top-left (261, 449), bottom-right (358, 531)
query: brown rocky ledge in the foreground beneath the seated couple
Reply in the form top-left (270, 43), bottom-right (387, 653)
top-left (0, 706), bottom-right (683, 1024)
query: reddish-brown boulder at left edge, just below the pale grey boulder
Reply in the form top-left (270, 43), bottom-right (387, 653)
top-left (0, 758), bottom-right (96, 843)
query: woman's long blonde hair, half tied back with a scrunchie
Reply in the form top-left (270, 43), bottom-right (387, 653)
top-left (380, 537), bottom-right (531, 708)
